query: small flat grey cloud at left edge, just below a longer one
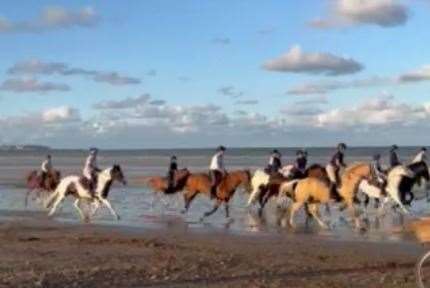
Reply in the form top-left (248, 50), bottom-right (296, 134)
top-left (0, 79), bottom-right (70, 93)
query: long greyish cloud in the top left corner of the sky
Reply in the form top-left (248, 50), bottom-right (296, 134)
top-left (0, 6), bottom-right (99, 33)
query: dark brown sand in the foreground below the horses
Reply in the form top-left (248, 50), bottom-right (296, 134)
top-left (0, 212), bottom-right (425, 287)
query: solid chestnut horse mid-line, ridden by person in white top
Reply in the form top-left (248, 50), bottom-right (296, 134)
top-left (183, 170), bottom-right (251, 218)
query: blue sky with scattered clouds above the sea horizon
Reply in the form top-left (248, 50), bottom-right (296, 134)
top-left (0, 0), bottom-right (430, 149)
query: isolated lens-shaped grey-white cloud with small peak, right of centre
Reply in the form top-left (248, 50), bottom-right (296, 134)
top-left (263, 46), bottom-right (363, 76)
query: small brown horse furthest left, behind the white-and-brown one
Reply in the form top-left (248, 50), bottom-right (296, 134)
top-left (25, 170), bottom-right (61, 207)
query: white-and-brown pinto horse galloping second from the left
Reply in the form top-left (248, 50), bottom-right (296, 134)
top-left (46, 165), bottom-right (127, 220)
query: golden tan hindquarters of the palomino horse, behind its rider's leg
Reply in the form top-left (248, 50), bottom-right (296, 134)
top-left (279, 177), bottom-right (336, 228)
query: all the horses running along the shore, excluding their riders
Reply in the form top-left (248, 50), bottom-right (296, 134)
top-left (26, 158), bottom-right (430, 227)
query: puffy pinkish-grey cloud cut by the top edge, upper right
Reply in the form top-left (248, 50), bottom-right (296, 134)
top-left (310, 0), bottom-right (409, 29)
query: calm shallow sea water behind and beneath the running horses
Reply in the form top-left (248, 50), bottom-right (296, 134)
top-left (0, 147), bottom-right (430, 239)
